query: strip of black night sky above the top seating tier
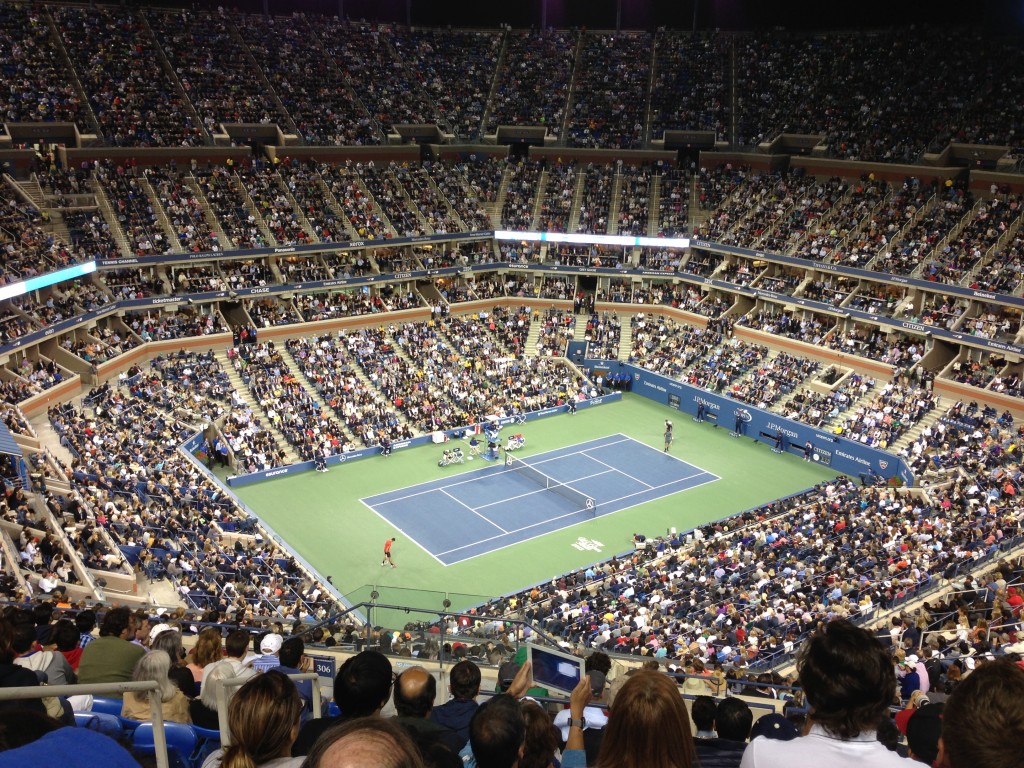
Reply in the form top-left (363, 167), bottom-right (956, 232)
top-left (201, 0), bottom-right (1024, 31)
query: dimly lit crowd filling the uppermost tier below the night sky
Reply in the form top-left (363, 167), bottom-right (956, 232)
top-left (5, 8), bottom-right (1024, 173)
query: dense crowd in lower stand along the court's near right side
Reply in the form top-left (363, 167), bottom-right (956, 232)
top-left (487, 466), bottom-right (1020, 684)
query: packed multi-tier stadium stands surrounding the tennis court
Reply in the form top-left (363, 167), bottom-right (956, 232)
top-left (0, 5), bottom-right (1024, 765)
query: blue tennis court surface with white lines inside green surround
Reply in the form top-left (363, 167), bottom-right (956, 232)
top-left (361, 434), bottom-right (720, 565)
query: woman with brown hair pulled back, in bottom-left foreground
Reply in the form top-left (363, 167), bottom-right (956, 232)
top-left (203, 670), bottom-right (305, 768)
